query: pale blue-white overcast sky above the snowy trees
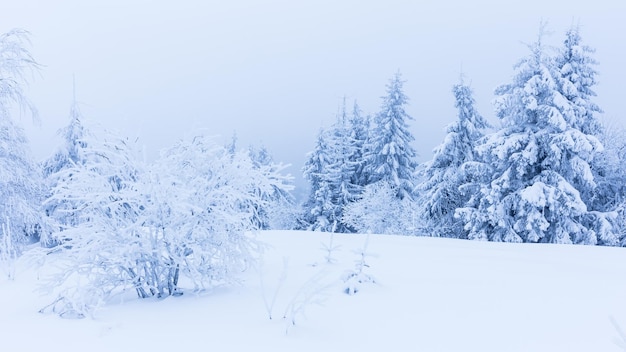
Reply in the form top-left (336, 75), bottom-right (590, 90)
top-left (0, 0), bottom-right (626, 192)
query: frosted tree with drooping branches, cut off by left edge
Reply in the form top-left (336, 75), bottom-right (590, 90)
top-left (0, 30), bottom-right (45, 252)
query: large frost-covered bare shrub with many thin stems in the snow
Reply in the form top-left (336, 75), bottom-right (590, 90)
top-left (37, 131), bottom-right (289, 315)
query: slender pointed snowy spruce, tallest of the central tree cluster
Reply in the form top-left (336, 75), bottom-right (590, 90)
top-left (364, 72), bottom-right (417, 199)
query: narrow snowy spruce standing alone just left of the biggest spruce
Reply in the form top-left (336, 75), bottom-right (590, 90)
top-left (418, 82), bottom-right (489, 238)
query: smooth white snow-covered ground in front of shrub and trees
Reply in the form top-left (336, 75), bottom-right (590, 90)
top-left (0, 231), bottom-right (626, 352)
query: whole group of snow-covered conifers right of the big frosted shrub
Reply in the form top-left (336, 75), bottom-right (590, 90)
top-left (300, 26), bottom-right (626, 245)
